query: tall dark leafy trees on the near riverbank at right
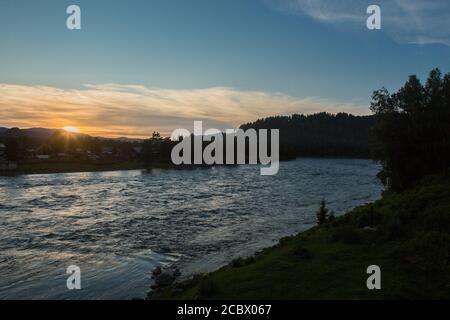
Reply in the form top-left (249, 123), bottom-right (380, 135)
top-left (371, 69), bottom-right (450, 191)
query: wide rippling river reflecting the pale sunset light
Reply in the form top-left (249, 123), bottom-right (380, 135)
top-left (0, 159), bottom-right (382, 299)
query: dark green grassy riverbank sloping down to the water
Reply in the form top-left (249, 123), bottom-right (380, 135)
top-left (153, 175), bottom-right (450, 299)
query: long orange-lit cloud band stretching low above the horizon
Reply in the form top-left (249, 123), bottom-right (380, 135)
top-left (0, 84), bottom-right (368, 137)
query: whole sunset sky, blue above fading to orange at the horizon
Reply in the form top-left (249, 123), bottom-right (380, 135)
top-left (0, 0), bottom-right (450, 137)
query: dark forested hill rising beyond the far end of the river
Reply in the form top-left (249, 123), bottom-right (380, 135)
top-left (241, 112), bottom-right (375, 159)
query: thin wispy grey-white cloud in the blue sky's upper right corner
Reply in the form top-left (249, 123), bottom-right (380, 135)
top-left (267, 0), bottom-right (450, 46)
